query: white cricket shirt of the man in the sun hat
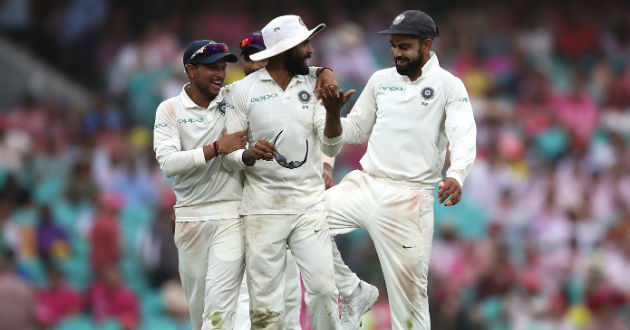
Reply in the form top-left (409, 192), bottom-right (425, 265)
top-left (224, 68), bottom-right (342, 215)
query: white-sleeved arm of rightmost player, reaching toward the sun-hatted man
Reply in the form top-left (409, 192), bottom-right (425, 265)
top-left (341, 74), bottom-right (377, 144)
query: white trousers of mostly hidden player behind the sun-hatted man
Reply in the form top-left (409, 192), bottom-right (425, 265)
top-left (234, 250), bottom-right (302, 330)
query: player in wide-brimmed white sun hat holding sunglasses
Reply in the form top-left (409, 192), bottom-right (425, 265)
top-left (224, 15), bottom-right (353, 330)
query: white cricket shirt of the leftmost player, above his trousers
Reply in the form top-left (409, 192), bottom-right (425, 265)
top-left (153, 84), bottom-right (243, 221)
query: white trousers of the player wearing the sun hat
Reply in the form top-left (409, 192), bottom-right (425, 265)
top-left (243, 212), bottom-right (339, 330)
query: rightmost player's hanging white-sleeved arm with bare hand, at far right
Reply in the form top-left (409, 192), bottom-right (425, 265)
top-left (438, 78), bottom-right (477, 206)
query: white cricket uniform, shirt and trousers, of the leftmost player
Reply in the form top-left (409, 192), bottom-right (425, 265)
top-left (153, 86), bottom-right (244, 330)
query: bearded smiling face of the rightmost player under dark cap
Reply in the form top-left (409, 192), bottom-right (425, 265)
top-left (390, 34), bottom-right (433, 80)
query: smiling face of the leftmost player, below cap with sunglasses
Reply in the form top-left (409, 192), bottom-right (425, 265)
top-left (186, 59), bottom-right (227, 100)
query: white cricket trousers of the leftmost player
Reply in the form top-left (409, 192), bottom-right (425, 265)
top-left (174, 219), bottom-right (245, 330)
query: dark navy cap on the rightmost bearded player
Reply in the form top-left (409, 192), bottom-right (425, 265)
top-left (378, 10), bottom-right (440, 39)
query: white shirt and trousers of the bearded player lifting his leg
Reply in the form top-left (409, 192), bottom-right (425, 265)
top-left (326, 52), bottom-right (476, 330)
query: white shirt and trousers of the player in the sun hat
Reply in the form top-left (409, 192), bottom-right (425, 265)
top-left (224, 69), bottom-right (342, 330)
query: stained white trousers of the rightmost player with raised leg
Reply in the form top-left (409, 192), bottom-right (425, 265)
top-left (326, 171), bottom-right (435, 330)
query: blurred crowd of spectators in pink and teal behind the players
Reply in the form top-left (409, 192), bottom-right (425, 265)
top-left (0, 0), bottom-right (630, 330)
